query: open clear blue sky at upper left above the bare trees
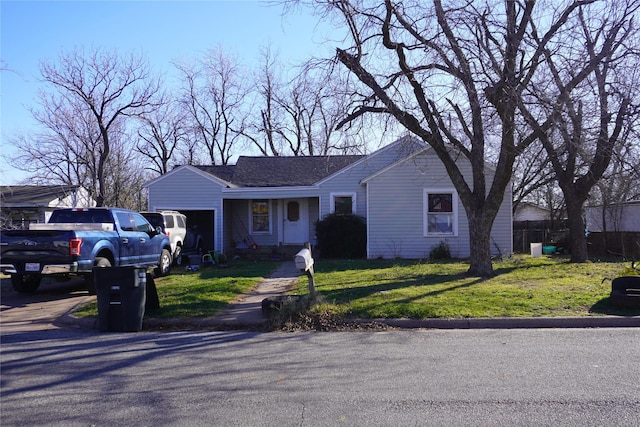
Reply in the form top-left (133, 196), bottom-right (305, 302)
top-left (0, 0), bottom-right (335, 185)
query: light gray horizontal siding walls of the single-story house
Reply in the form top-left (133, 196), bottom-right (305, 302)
top-left (142, 138), bottom-right (513, 258)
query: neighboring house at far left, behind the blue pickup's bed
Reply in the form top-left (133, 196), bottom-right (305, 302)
top-left (0, 185), bottom-right (96, 229)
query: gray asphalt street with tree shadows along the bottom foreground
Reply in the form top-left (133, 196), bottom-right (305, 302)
top-left (0, 328), bottom-right (640, 426)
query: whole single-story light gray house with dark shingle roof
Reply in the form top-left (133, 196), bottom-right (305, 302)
top-left (146, 138), bottom-right (513, 258)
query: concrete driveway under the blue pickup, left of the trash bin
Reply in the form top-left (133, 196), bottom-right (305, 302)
top-left (0, 276), bottom-right (95, 334)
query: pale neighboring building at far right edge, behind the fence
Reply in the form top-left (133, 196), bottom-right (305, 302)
top-left (586, 200), bottom-right (640, 232)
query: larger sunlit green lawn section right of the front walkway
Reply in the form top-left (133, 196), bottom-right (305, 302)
top-left (298, 256), bottom-right (640, 319)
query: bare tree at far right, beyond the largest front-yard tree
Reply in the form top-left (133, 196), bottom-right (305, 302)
top-left (520, 0), bottom-right (640, 262)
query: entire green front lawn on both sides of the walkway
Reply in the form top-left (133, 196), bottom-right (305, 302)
top-left (76, 256), bottom-right (640, 319)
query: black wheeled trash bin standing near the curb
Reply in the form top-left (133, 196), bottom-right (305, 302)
top-left (93, 267), bottom-right (147, 332)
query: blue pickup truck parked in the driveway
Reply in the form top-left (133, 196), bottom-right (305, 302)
top-left (0, 208), bottom-right (172, 293)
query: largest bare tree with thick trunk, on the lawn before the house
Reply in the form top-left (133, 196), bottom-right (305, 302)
top-left (294, 0), bottom-right (604, 276)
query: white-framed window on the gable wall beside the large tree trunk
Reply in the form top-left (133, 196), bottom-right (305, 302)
top-left (424, 190), bottom-right (458, 236)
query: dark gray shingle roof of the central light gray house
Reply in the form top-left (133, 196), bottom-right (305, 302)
top-left (197, 155), bottom-right (365, 187)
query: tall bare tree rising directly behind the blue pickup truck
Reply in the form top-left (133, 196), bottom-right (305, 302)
top-left (31, 49), bottom-right (159, 206)
